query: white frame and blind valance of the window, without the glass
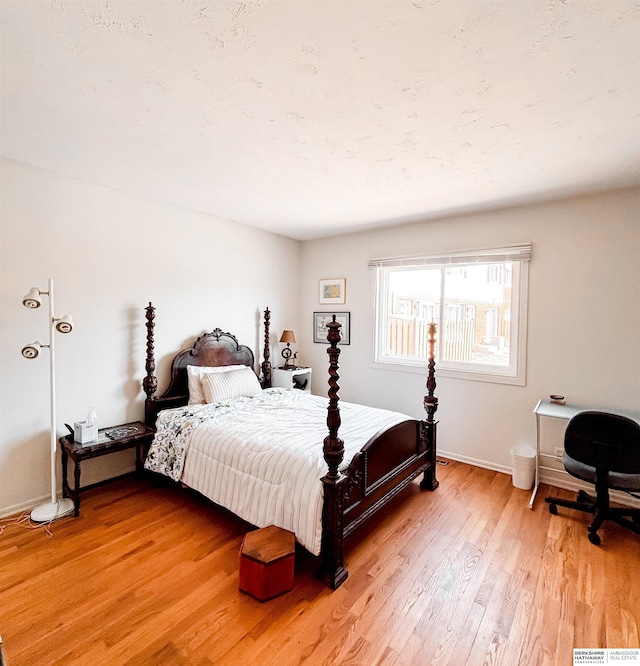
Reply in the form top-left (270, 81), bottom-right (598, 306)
top-left (369, 243), bottom-right (531, 386)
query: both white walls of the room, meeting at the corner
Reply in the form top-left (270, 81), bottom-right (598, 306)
top-left (0, 160), bottom-right (640, 515)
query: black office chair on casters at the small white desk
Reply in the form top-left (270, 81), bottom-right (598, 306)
top-left (545, 411), bottom-right (640, 546)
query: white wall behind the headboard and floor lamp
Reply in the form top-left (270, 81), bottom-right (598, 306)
top-left (0, 160), bottom-right (300, 515)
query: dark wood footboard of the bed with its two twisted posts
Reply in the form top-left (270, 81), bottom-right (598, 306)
top-left (319, 316), bottom-right (438, 589)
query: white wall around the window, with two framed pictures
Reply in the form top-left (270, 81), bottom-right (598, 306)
top-left (300, 189), bottom-right (640, 471)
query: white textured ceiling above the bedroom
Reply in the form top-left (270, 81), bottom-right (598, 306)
top-left (0, 0), bottom-right (640, 239)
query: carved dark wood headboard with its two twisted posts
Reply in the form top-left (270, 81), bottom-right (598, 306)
top-left (142, 303), bottom-right (271, 427)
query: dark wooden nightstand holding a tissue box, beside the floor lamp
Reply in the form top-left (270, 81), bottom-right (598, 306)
top-left (58, 421), bottom-right (155, 516)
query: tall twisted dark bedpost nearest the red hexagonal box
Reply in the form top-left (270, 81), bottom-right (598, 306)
top-left (319, 315), bottom-right (349, 590)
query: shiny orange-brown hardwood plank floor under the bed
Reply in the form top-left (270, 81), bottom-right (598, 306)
top-left (0, 462), bottom-right (640, 666)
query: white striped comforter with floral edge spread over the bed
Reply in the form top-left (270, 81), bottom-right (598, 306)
top-left (145, 388), bottom-right (410, 555)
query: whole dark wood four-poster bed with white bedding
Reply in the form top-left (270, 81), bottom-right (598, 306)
top-left (143, 303), bottom-right (438, 589)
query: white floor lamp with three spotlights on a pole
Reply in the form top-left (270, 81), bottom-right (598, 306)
top-left (22, 278), bottom-right (74, 523)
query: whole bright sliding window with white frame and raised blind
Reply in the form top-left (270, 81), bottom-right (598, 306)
top-left (369, 245), bottom-right (531, 385)
